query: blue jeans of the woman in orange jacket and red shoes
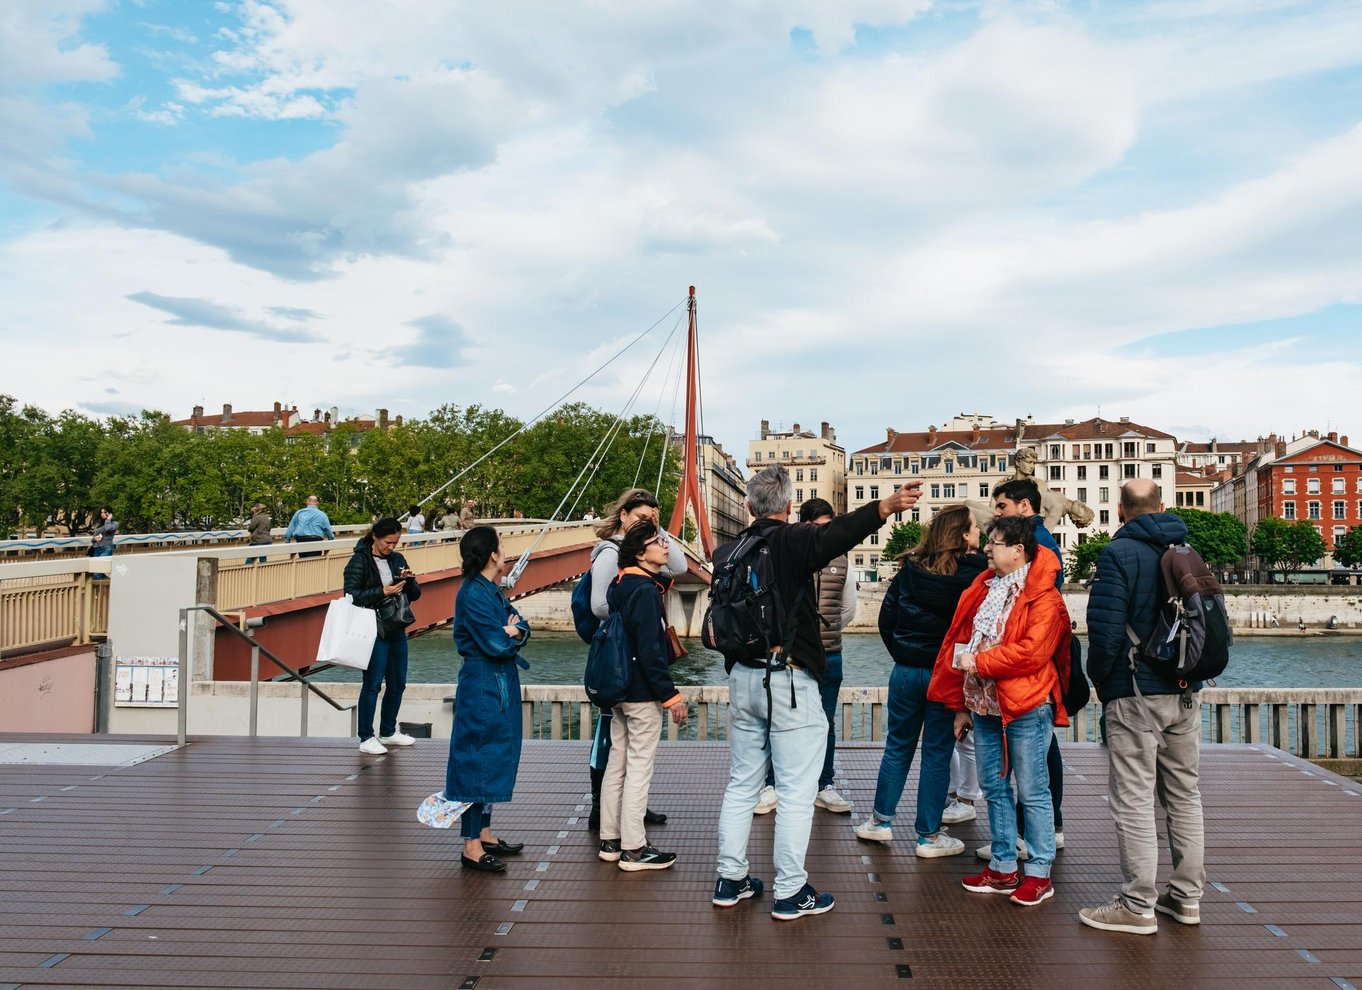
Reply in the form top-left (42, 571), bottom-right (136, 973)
top-left (974, 704), bottom-right (1054, 877)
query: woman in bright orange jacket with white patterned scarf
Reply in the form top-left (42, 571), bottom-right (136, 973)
top-left (928, 517), bottom-right (1071, 907)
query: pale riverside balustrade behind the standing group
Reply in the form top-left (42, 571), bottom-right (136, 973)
top-left (520, 685), bottom-right (1362, 759)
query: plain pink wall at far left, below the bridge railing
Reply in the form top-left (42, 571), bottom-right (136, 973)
top-left (0, 648), bottom-right (95, 733)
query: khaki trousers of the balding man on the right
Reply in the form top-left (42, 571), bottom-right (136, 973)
top-left (1105, 694), bottom-right (1205, 915)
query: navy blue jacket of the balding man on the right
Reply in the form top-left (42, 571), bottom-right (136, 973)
top-left (1088, 512), bottom-right (1188, 704)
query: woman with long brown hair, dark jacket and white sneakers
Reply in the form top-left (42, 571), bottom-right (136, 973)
top-left (855, 505), bottom-right (987, 858)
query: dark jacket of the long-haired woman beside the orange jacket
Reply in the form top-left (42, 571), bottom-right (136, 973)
top-left (880, 553), bottom-right (989, 670)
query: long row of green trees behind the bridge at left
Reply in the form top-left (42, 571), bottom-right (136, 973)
top-left (0, 395), bottom-right (680, 532)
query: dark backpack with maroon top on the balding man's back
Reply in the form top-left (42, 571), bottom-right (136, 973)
top-left (1125, 543), bottom-right (1234, 689)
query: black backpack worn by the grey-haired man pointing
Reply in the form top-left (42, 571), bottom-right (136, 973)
top-left (700, 530), bottom-right (804, 670)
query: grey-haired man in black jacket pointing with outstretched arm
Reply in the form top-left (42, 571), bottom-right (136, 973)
top-left (714, 466), bottom-right (921, 921)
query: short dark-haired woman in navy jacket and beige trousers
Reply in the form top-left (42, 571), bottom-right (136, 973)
top-left (598, 519), bottom-right (686, 872)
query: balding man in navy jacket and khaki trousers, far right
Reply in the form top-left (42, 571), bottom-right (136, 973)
top-left (1079, 478), bottom-right (1205, 936)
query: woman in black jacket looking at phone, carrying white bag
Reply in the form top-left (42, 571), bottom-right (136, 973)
top-left (345, 516), bottom-right (421, 756)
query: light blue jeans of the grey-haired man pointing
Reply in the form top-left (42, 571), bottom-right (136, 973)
top-left (719, 666), bottom-right (828, 899)
